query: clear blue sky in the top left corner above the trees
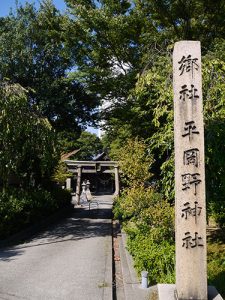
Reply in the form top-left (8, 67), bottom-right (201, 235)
top-left (0, 0), bottom-right (66, 17)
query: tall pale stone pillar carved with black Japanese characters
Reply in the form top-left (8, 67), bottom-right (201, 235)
top-left (173, 41), bottom-right (208, 300)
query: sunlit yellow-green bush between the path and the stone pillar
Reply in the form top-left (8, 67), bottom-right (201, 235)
top-left (114, 186), bottom-right (175, 284)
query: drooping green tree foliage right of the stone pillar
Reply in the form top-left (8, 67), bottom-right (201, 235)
top-left (203, 40), bottom-right (225, 226)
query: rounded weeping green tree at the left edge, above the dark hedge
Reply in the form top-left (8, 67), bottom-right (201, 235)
top-left (0, 83), bottom-right (59, 187)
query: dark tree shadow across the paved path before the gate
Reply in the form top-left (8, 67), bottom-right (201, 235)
top-left (0, 196), bottom-right (112, 262)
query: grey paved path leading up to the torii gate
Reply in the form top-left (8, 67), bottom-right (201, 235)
top-left (0, 196), bottom-right (112, 300)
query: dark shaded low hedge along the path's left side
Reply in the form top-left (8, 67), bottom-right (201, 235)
top-left (0, 188), bottom-right (70, 238)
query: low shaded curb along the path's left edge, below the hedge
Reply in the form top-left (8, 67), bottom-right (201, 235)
top-left (0, 207), bottom-right (73, 248)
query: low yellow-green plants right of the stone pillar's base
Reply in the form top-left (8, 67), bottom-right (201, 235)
top-left (207, 229), bottom-right (225, 298)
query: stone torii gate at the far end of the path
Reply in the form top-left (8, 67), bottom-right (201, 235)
top-left (64, 160), bottom-right (120, 203)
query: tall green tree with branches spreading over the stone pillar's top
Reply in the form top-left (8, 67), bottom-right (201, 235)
top-left (65, 0), bottom-right (225, 105)
